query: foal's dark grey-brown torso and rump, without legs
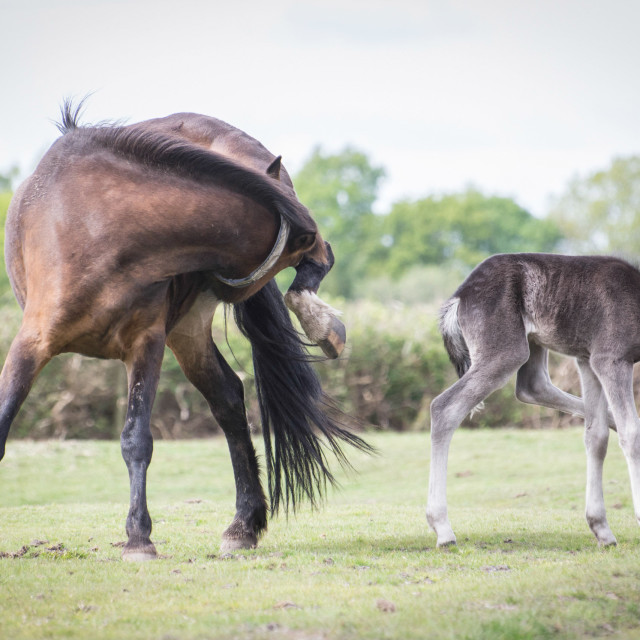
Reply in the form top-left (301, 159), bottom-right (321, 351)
top-left (454, 253), bottom-right (640, 362)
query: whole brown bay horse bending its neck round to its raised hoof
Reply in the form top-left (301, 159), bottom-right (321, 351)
top-left (0, 103), bottom-right (368, 560)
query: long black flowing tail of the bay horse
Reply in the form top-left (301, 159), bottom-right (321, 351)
top-left (234, 280), bottom-right (373, 512)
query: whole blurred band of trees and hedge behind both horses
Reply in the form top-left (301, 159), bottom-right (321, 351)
top-left (0, 152), bottom-right (640, 438)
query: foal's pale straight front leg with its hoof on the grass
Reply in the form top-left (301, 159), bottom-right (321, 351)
top-left (576, 358), bottom-right (616, 546)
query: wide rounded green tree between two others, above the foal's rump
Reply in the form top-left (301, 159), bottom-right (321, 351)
top-left (379, 189), bottom-right (561, 276)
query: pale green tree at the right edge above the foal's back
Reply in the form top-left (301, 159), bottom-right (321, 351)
top-left (551, 156), bottom-right (640, 256)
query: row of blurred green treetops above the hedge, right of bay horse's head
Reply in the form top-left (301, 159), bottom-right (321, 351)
top-left (295, 147), bottom-right (640, 301)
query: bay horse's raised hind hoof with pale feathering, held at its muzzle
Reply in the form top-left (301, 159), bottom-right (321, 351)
top-left (284, 242), bottom-right (347, 358)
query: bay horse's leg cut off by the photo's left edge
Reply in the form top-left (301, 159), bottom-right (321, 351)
top-left (0, 325), bottom-right (50, 460)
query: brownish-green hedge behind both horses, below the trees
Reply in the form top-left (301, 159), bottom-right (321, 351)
top-left (0, 301), bottom-right (592, 439)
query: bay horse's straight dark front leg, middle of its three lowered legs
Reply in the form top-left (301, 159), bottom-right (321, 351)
top-left (120, 335), bottom-right (164, 561)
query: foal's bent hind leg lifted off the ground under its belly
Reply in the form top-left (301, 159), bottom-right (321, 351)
top-left (516, 342), bottom-right (615, 429)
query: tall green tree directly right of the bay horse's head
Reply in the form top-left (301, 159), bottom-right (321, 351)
top-left (294, 147), bottom-right (385, 297)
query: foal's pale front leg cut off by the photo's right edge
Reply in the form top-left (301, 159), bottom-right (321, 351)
top-left (590, 356), bottom-right (640, 524)
